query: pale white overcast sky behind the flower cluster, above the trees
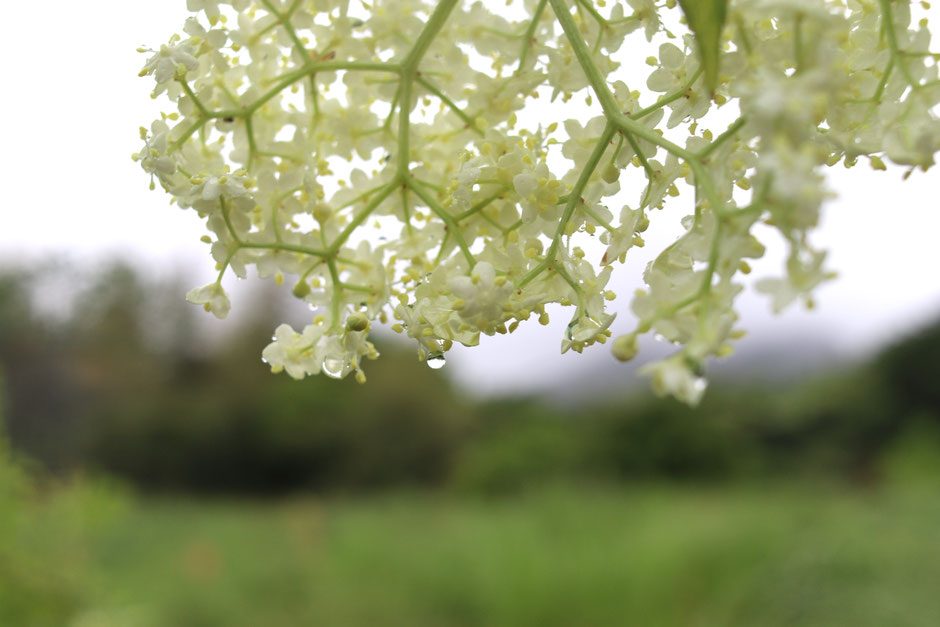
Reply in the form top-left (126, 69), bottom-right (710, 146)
top-left (0, 0), bottom-right (940, 398)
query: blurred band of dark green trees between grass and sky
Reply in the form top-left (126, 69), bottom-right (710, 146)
top-left (0, 263), bottom-right (940, 493)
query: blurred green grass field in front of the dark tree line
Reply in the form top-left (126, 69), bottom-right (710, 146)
top-left (60, 486), bottom-right (940, 627)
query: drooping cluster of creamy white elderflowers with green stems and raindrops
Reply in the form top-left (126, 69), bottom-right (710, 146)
top-left (134, 0), bottom-right (940, 403)
